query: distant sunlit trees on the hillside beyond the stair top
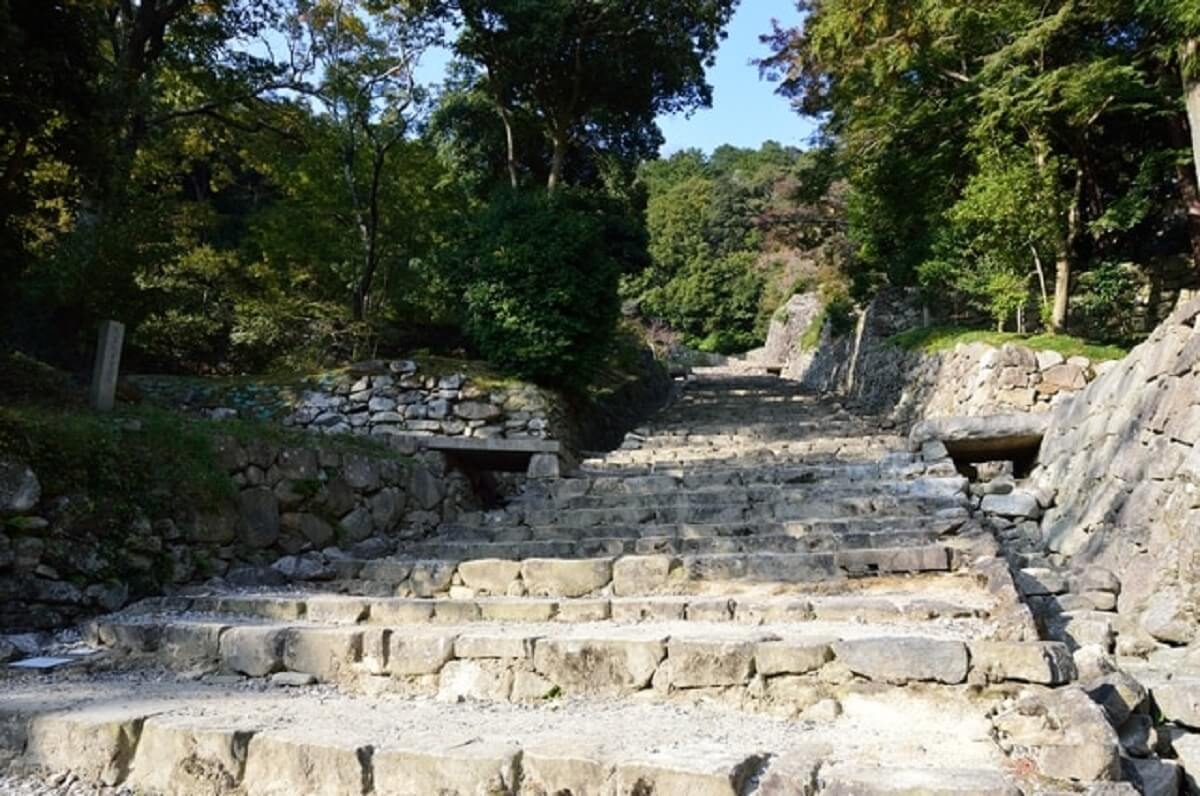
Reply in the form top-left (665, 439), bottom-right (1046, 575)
top-left (623, 143), bottom-right (844, 353)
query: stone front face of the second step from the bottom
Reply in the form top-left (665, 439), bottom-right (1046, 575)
top-left (88, 621), bottom-right (1078, 702)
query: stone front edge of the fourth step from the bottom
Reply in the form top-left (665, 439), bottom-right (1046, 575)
top-left (270, 544), bottom-right (962, 598)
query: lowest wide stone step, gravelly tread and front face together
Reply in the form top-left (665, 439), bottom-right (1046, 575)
top-left (0, 675), bottom-right (1051, 796)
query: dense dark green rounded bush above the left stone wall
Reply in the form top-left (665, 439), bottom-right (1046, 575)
top-left (464, 191), bottom-right (644, 387)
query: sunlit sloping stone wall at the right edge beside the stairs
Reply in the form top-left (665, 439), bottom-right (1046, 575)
top-left (1032, 300), bottom-right (1200, 653)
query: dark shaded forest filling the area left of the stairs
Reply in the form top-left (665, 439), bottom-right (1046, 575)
top-left (0, 0), bottom-right (736, 382)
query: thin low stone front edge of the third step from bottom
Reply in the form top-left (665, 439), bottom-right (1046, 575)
top-left (121, 585), bottom-right (990, 626)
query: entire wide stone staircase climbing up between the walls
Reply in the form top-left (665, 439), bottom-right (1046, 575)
top-left (0, 370), bottom-right (1134, 796)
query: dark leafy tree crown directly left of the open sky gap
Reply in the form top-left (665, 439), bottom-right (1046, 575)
top-left (436, 0), bottom-right (737, 188)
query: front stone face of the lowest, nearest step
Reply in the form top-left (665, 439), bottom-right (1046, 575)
top-left (10, 704), bottom-right (1036, 796)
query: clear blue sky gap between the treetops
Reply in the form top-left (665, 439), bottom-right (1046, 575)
top-left (659, 0), bottom-right (814, 155)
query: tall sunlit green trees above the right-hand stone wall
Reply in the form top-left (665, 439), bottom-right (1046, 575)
top-left (763, 0), bottom-right (1200, 329)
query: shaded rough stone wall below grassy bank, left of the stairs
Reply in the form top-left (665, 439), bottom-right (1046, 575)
top-left (0, 438), bottom-right (478, 630)
